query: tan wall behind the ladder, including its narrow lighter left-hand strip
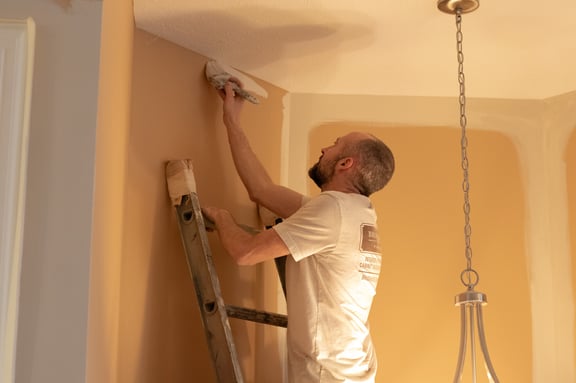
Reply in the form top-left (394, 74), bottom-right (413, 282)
top-left (93, 1), bottom-right (284, 383)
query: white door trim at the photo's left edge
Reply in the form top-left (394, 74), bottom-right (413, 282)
top-left (0, 18), bottom-right (35, 383)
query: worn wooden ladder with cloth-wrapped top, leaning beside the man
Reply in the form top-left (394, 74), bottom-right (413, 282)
top-left (166, 160), bottom-right (288, 383)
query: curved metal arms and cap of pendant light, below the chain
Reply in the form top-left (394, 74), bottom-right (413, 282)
top-left (454, 288), bottom-right (500, 383)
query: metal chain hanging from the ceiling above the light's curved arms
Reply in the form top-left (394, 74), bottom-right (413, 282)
top-left (456, 9), bottom-right (479, 289)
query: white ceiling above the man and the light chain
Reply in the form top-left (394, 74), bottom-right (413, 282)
top-left (134, 0), bottom-right (576, 99)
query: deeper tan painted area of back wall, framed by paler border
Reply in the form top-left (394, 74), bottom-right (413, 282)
top-left (309, 123), bottom-right (531, 383)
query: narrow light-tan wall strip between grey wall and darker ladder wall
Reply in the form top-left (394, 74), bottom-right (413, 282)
top-left (86, 1), bottom-right (134, 383)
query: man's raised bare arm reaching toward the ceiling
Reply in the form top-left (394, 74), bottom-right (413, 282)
top-left (220, 83), bottom-right (302, 218)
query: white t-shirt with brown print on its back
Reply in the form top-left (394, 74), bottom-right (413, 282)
top-left (274, 191), bottom-right (381, 383)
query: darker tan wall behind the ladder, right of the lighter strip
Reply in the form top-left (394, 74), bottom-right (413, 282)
top-left (118, 30), bottom-right (283, 383)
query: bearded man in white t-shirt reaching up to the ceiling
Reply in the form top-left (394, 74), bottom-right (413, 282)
top-left (203, 79), bottom-right (394, 383)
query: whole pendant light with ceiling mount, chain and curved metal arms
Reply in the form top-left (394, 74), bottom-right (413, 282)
top-left (437, 0), bottom-right (499, 383)
